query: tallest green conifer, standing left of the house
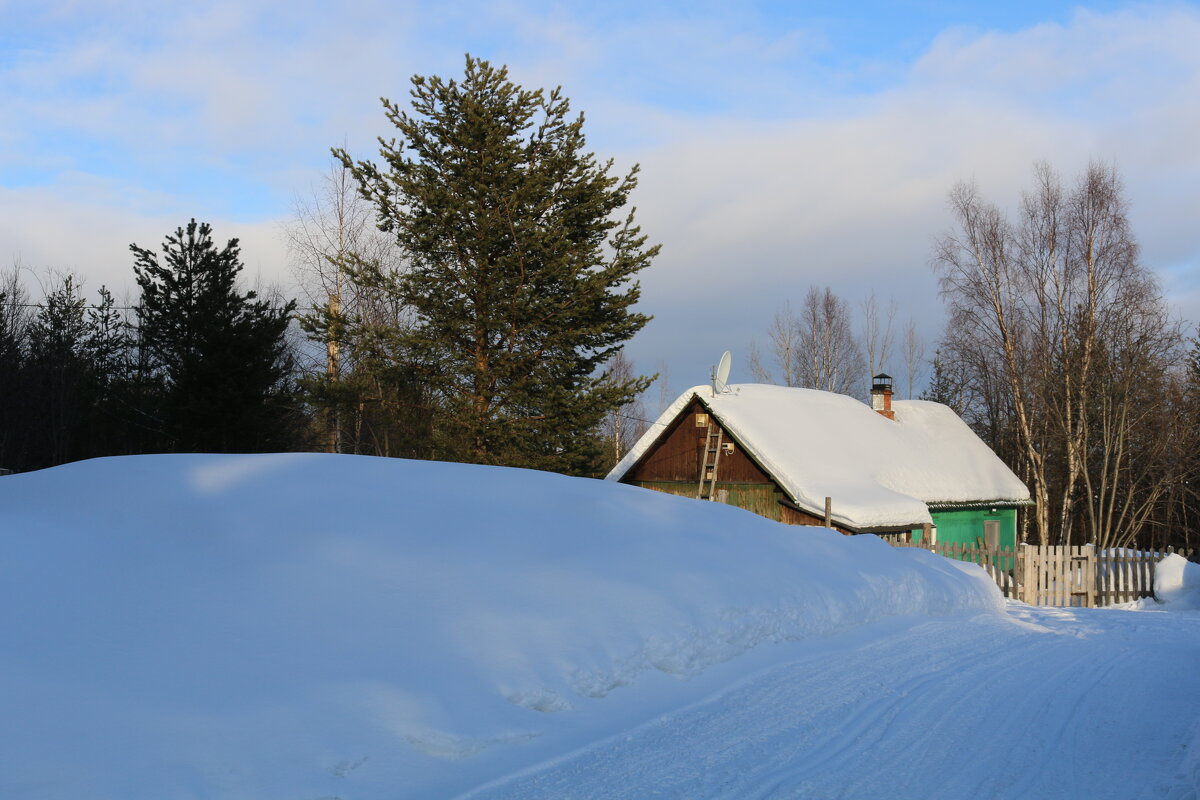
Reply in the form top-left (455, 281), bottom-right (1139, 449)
top-left (335, 55), bottom-right (659, 473)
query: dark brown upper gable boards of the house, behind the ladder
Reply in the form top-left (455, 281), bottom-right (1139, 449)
top-left (622, 401), bottom-right (774, 486)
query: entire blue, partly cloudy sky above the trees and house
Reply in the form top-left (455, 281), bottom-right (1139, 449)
top-left (0, 0), bottom-right (1200, 389)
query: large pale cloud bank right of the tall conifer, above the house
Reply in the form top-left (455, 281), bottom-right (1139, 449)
top-left (630, 10), bottom-right (1200, 384)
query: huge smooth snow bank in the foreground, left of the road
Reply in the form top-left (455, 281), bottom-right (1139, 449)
top-left (0, 455), bottom-right (1002, 800)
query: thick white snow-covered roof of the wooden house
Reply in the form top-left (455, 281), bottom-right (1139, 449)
top-left (607, 384), bottom-right (1030, 530)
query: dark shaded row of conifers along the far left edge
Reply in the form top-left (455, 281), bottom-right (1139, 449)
top-left (0, 221), bottom-right (307, 471)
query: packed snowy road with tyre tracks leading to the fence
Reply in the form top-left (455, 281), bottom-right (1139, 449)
top-left (467, 606), bottom-right (1200, 800)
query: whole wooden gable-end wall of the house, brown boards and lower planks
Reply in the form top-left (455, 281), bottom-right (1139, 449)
top-left (622, 399), bottom-right (850, 534)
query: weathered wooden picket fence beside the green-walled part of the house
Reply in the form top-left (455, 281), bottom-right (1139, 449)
top-left (890, 541), bottom-right (1195, 608)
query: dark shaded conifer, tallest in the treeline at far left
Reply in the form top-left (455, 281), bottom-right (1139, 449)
top-left (130, 219), bottom-right (295, 452)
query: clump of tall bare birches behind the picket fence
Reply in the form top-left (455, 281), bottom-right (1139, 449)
top-left (935, 163), bottom-right (1181, 545)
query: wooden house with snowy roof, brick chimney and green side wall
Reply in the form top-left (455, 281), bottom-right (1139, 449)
top-left (607, 375), bottom-right (1030, 546)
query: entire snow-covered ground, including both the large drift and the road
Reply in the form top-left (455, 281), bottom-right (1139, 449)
top-left (0, 455), bottom-right (1200, 800)
